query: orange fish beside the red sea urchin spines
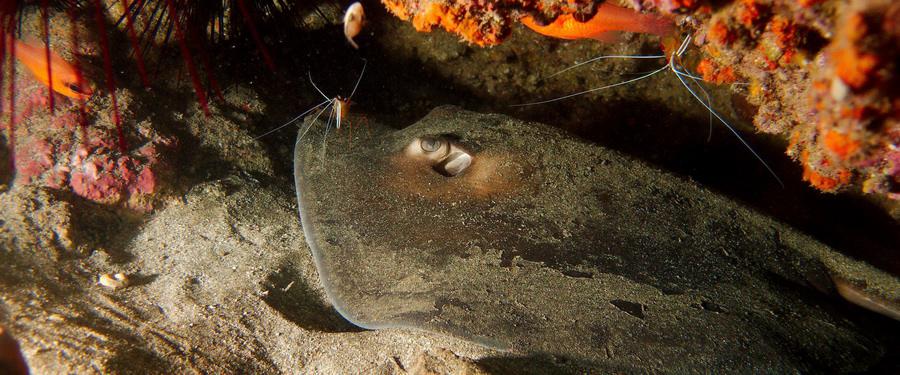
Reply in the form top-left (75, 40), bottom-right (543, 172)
top-left (15, 40), bottom-right (93, 100)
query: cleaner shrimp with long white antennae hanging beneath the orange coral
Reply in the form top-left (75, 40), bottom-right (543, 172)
top-left (511, 35), bottom-right (784, 187)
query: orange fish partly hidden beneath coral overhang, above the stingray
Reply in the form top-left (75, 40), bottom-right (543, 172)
top-left (522, 2), bottom-right (673, 41)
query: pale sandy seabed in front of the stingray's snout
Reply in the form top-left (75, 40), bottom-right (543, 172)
top-left (0, 181), bottom-right (489, 374)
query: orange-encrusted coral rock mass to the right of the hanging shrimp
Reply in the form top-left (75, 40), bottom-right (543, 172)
top-left (664, 0), bottom-right (900, 199)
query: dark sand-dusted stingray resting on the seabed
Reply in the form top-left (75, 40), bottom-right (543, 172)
top-left (294, 107), bottom-right (900, 372)
